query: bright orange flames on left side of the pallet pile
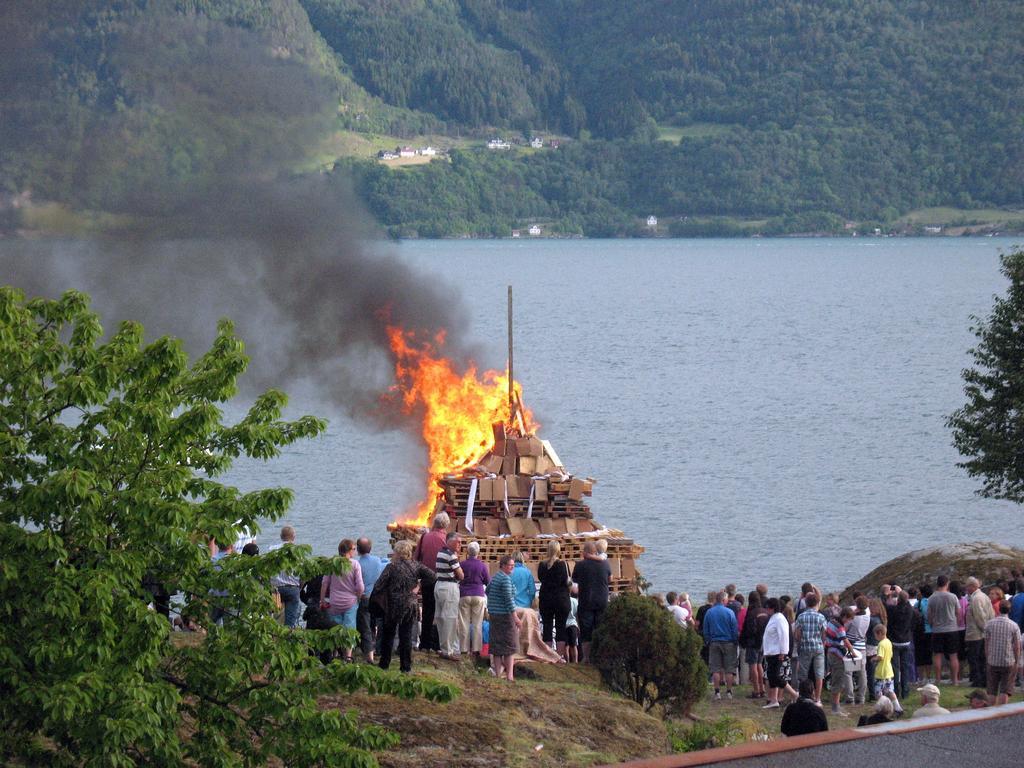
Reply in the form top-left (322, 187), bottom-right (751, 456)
top-left (387, 326), bottom-right (539, 525)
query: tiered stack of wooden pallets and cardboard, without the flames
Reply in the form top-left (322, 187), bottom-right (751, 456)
top-left (391, 424), bottom-right (644, 592)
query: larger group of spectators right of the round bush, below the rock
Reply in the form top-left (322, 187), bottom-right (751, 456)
top-left (665, 571), bottom-right (1024, 735)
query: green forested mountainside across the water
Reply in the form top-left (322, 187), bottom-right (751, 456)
top-left (0, 0), bottom-right (1024, 237)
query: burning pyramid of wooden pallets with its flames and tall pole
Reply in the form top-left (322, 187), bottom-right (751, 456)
top-left (387, 287), bottom-right (643, 592)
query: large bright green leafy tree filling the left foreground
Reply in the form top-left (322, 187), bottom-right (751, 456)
top-left (0, 287), bottom-right (455, 766)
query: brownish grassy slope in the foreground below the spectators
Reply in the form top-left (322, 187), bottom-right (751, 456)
top-left (325, 653), bottom-right (999, 768)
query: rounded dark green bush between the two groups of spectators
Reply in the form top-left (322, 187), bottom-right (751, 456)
top-left (591, 594), bottom-right (708, 715)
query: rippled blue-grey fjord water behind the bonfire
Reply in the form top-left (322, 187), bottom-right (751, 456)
top-left (232, 238), bottom-right (1024, 602)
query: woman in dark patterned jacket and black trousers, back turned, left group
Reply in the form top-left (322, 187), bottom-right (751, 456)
top-left (370, 541), bottom-right (434, 673)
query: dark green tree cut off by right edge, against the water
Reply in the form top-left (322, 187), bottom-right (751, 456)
top-left (948, 249), bottom-right (1024, 503)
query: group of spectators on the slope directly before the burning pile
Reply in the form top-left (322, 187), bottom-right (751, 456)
top-left (190, 513), bottom-right (611, 680)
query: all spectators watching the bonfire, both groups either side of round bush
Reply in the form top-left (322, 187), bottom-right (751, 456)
top-left (180, 524), bottom-right (1024, 734)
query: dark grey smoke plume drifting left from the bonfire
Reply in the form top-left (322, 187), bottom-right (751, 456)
top-left (0, 4), bottom-right (477, 418)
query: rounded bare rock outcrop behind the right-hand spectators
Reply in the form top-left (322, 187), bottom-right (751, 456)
top-left (843, 542), bottom-right (1024, 599)
